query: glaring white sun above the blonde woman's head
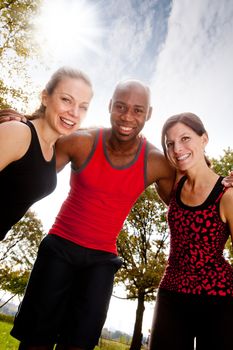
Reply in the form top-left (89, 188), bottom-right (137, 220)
top-left (35, 0), bottom-right (102, 60)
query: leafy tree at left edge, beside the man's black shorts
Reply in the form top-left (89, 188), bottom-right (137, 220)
top-left (0, 211), bottom-right (45, 304)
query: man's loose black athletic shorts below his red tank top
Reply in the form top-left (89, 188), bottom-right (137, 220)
top-left (11, 235), bottom-right (122, 350)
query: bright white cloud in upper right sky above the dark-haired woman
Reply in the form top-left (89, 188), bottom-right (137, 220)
top-left (146, 0), bottom-right (233, 156)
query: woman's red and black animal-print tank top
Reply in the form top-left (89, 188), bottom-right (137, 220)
top-left (160, 177), bottom-right (233, 296)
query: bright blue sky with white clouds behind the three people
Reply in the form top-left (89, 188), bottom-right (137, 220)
top-left (27, 0), bottom-right (233, 332)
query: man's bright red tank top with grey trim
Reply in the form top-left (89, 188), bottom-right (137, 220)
top-left (49, 129), bottom-right (147, 254)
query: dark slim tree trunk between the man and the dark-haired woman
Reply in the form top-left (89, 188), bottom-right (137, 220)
top-left (129, 293), bottom-right (145, 350)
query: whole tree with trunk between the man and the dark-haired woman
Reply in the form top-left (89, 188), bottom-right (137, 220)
top-left (115, 187), bottom-right (168, 350)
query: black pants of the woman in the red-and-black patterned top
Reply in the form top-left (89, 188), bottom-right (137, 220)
top-left (149, 290), bottom-right (233, 350)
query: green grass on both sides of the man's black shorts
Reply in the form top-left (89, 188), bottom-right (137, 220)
top-left (0, 321), bottom-right (129, 350)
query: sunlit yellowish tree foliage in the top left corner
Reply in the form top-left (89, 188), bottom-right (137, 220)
top-left (0, 0), bottom-right (41, 108)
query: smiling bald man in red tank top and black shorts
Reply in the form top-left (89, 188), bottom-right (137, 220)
top-left (3, 80), bottom-right (233, 350)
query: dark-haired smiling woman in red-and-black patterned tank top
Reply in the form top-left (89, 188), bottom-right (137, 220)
top-left (150, 113), bottom-right (233, 350)
